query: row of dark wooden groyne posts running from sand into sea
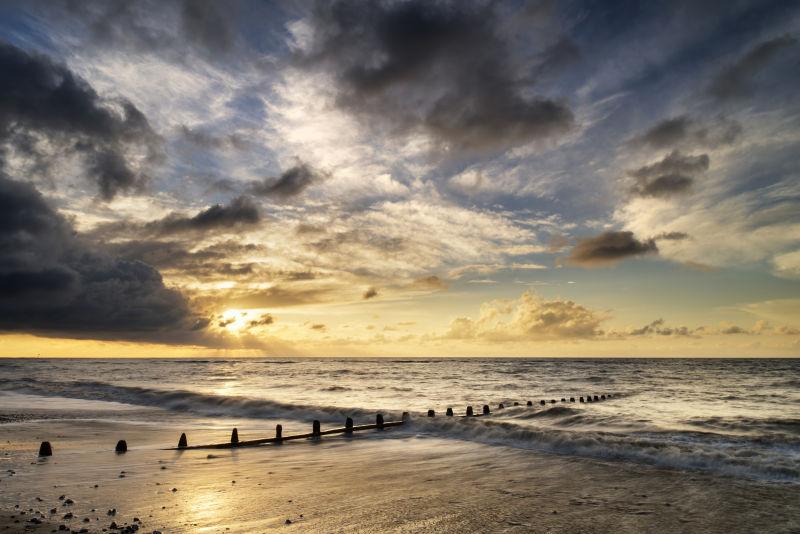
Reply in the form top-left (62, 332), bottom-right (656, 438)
top-left (39, 394), bottom-right (613, 456)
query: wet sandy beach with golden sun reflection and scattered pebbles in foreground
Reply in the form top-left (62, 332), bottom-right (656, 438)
top-left (0, 421), bottom-right (800, 533)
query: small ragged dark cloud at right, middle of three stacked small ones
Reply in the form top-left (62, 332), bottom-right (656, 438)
top-left (628, 150), bottom-right (710, 198)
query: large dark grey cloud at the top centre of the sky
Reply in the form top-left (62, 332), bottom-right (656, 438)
top-left (299, 0), bottom-right (576, 152)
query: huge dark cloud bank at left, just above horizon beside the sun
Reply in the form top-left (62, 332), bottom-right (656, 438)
top-left (0, 176), bottom-right (202, 340)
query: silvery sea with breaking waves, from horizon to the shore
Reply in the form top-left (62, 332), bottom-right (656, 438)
top-left (0, 358), bottom-right (800, 484)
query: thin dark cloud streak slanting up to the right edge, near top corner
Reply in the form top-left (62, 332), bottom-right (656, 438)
top-left (708, 35), bottom-right (797, 101)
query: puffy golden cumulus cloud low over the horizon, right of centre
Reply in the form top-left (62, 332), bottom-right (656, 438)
top-left (444, 291), bottom-right (605, 342)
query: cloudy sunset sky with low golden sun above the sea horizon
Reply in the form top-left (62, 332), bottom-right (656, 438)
top-left (0, 0), bottom-right (800, 357)
